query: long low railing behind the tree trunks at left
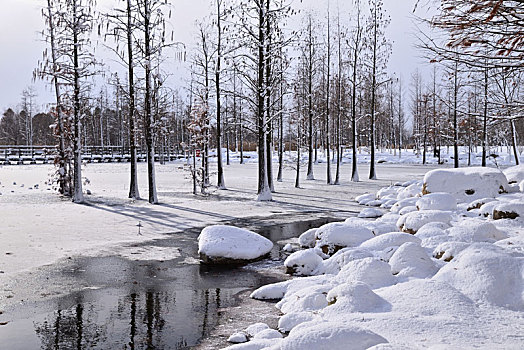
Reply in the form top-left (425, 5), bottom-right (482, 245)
top-left (0, 145), bottom-right (186, 165)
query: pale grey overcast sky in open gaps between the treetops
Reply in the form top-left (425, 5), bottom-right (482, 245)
top-left (0, 0), bottom-right (427, 113)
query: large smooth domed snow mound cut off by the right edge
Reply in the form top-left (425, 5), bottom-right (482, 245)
top-left (433, 243), bottom-right (524, 311)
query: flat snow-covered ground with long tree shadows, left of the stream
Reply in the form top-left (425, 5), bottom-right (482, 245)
top-left (0, 163), bottom-right (434, 296)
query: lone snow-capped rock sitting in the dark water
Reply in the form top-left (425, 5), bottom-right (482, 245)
top-left (198, 225), bottom-right (273, 264)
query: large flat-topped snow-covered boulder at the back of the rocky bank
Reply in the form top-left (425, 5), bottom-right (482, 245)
top-left (422, 167), bottom-right (508, 202)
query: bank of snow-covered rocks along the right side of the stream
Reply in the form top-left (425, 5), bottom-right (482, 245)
top-left (228, 165), bottom-right (524, 350)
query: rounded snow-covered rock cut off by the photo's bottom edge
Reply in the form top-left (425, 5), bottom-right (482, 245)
top-left (280, 321), bottom-right (387, 350)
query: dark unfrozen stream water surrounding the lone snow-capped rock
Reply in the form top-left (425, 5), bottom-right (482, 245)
top-left (0, 218), bottom-right (333, 350)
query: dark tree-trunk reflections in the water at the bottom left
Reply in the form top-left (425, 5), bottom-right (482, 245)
top-left (35, 288), bottom-right (234, 350)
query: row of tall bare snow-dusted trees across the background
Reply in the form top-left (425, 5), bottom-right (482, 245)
top-left (0, 0), bottom-right (523, 203)
